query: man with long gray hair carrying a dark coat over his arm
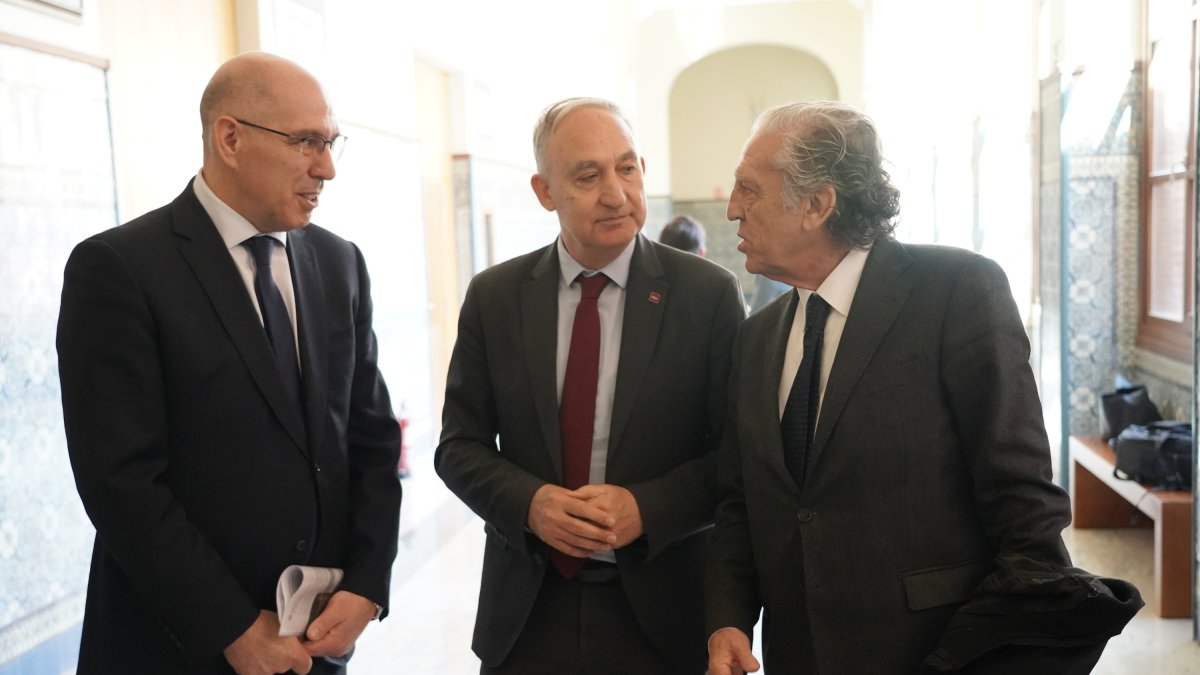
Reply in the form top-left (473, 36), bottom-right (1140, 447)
top-left (706, 103), bottom-right (1140, 675)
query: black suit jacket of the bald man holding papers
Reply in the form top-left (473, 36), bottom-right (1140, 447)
top-left (58, 184), bottom-right (401, 674)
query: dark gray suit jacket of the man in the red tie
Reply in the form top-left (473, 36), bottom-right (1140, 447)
top-left (434, 235), bottom-right (744, 673)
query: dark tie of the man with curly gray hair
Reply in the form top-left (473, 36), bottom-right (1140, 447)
top-left (779, 293), bottom-right (829, 486)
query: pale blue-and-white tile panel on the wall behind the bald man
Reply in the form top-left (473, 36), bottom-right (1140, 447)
top-left (0, 44), bottom-right (116, 663)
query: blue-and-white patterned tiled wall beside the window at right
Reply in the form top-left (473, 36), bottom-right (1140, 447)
top-left (1039, 67), bottom-right (1200, 634)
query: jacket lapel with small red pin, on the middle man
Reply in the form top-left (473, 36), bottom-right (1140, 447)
top-left (608, 234), bottom-right (671, 458)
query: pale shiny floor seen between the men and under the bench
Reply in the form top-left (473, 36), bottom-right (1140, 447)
top-left (350, 444), bottom-right (1200, 675)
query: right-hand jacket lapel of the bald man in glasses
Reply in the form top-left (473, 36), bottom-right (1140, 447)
top-left (288, 229), bottom-right (329, 456)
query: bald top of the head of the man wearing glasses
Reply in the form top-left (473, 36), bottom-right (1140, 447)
top-left (200, 52), bottom-right (322, 153)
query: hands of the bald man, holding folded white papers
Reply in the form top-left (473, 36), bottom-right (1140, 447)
top-left (224, 591), bottom-right (374, 675)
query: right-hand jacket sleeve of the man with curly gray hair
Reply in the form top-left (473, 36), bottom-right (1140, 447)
top-left (941, 257), bottom-right (1070, 565)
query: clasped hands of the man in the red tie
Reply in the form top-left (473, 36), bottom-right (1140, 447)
top-left (528, 483), bottom-right (643, 557)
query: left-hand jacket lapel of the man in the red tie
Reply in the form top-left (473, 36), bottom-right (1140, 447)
top-left (521, 245), bottom-right (563, 483)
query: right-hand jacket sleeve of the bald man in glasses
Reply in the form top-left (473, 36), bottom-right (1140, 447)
top-left (342, 242), bottom-right (402, 610)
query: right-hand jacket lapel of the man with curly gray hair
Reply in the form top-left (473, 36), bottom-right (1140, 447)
top-left (809, 240), bottom-right (913, 466)
